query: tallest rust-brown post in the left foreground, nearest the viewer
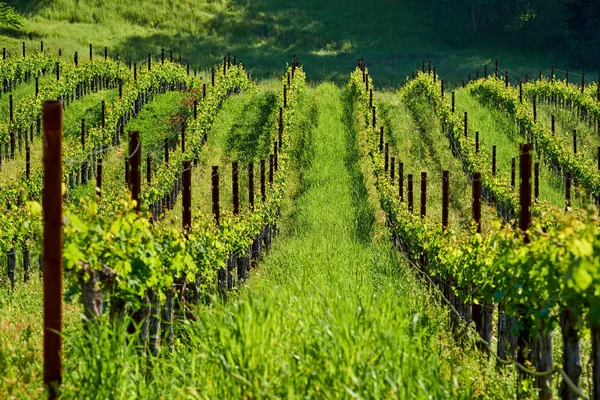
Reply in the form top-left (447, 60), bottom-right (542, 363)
top-left (42, 101), bottom-right (63, 399)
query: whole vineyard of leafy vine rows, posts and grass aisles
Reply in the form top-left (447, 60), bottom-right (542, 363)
top-left (0, 43), bottom-right (600, 399)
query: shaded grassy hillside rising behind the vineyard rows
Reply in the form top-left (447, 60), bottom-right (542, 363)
top-left (0, 0), bottom-right (593, 86)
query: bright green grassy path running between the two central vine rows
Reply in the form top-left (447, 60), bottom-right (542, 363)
top-left (169, 84), bottom-right (510, 398)
